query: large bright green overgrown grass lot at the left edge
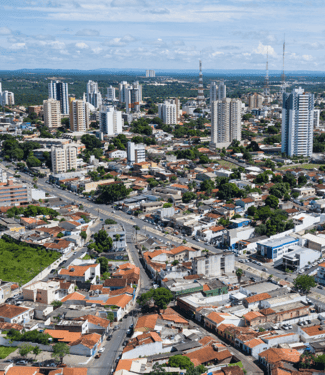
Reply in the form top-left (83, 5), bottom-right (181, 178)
top-left (0, 235), bottom-right (61, 284)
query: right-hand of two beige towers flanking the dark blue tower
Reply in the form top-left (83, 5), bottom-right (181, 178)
top-left (69, 97), bottom-right (90, 132)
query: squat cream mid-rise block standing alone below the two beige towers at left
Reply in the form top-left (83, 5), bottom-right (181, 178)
top-left (51, 144), bottom-right (78, 174)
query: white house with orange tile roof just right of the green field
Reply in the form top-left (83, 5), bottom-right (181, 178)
top-left (58, 263), bottom-right (100, 284)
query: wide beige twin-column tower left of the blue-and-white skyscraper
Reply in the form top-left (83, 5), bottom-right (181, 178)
top-left (211, 98), bottom-right (242, 145)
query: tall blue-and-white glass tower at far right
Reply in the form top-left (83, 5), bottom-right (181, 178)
top-left (281, 87), bottom-right (314, 156)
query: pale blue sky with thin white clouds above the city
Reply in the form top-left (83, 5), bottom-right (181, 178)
top-left (0, 0), bottom-right (325, 71)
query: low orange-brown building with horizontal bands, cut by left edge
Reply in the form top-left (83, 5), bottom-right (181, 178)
top-left (0, 177), bottom-right (32, 207)
